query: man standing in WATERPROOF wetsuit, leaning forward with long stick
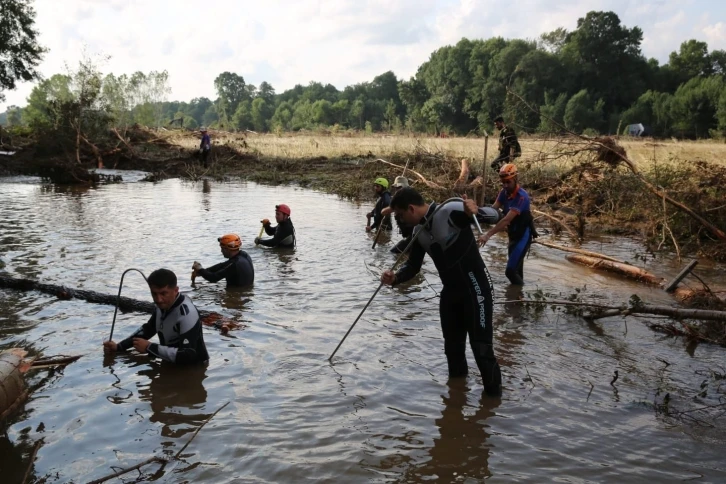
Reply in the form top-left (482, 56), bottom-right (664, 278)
top-left (381, 188), bottom-right (502, 396)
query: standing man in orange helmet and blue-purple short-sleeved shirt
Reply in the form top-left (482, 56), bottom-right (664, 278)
top-left (477, 163), bottom-right (537, 286)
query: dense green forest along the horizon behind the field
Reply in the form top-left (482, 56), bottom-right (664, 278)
top-left (0, 11), bottom-right (726, 138)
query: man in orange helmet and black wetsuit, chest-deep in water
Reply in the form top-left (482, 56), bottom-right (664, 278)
top-left (192, 234), bottom-right (255, 287)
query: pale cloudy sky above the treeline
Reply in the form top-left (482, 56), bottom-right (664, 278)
top-left (0, 0), bottom-right (726, 112)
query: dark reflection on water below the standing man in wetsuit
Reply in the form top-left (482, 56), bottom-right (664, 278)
top-left (400, 379), bottom-right (501, 482)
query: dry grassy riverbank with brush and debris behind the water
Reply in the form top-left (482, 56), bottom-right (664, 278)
top-left (0, 128), bottom-right (726, 260)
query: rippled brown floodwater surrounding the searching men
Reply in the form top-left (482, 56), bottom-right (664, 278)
top-left (0, 174), bottom-right (726, 483)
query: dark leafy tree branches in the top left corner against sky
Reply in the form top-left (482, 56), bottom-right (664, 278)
top-left (0, 0), bottom-right (46, 101)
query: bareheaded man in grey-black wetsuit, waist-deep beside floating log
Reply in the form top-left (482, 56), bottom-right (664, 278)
top-left (103, 269), bottom-right (209, 364)
